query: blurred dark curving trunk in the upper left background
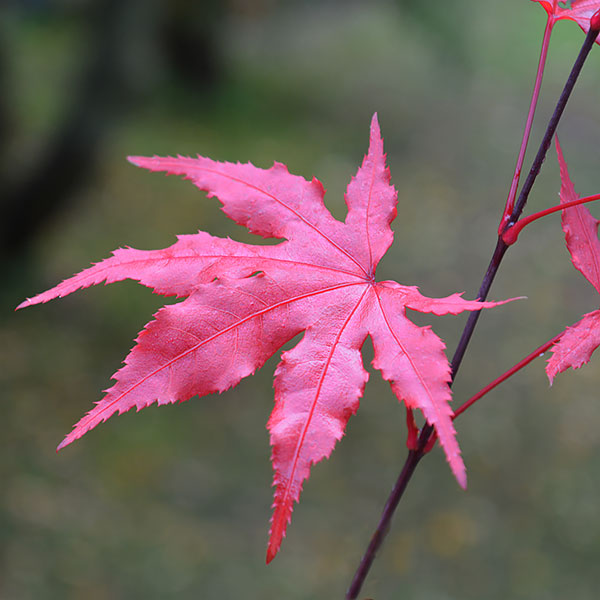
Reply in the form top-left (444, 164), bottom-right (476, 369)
top-left (0, 0), bottom-right (137, 260)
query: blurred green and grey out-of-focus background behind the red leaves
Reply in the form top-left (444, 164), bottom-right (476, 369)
top-left (0, 0), bottom-right (600, 600)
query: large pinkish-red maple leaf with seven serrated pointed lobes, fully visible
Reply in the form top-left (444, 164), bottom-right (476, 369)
top-left (19, 115), bottom-right (512, 561)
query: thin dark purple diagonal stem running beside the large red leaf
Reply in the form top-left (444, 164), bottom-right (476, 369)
top-left (346, 19), bottom-right (600, 600)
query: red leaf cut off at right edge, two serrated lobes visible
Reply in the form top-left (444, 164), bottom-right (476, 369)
top-left (546, 138), bottom-right (600, 383)
